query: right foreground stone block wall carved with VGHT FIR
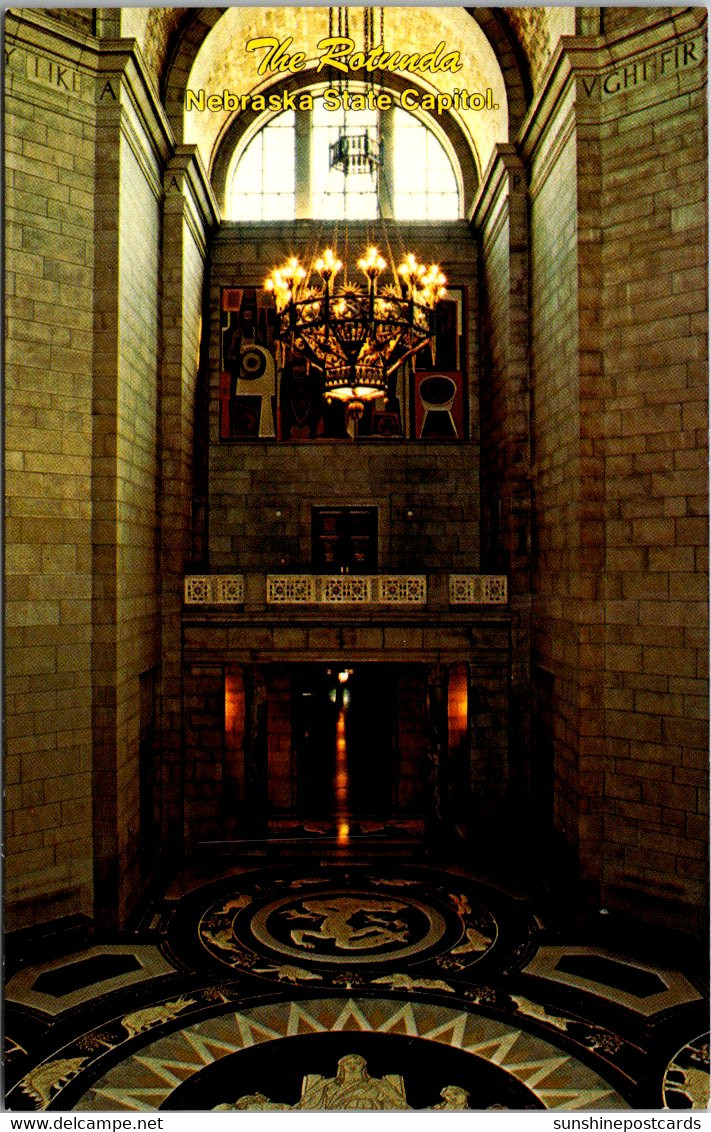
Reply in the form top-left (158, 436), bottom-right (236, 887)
top-left (598, 9), bottom-right (709, 926)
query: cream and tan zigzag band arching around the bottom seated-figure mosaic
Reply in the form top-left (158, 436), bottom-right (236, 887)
top-left (55, 997), bottom-right (629, 1112)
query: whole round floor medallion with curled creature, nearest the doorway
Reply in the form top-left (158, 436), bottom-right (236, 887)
top-left (171, 868), bottom-right (499, 989)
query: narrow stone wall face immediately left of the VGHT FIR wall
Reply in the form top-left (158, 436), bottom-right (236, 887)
top-left (530, 86), bottom-right (581, 864)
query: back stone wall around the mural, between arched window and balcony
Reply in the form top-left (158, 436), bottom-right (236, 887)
top-left (209, 222), bottom-right (479, 573)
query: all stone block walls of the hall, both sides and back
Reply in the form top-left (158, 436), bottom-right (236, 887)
top-left (5, 8), bottom-right (708, 928)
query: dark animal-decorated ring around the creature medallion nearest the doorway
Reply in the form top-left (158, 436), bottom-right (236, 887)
top-left (180, 866), bottom-right (499, 991)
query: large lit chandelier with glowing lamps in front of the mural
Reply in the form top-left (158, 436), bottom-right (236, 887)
top-left (265, 247), bottom-right (446, 417)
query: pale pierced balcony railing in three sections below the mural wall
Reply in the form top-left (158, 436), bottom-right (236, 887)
top-left (185, 574), bottom-right (508, 607)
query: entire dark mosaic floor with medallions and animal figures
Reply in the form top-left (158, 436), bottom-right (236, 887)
top-left (6, 863), bottom-right (709, 1112)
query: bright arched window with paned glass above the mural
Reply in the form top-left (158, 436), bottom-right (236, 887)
top-left (226, 92), bottom-right (462, 221)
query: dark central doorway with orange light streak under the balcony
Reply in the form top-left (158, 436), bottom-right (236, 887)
top-left (292, 663), bottom-right (397, 818)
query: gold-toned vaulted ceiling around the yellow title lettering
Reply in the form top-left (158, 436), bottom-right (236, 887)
top-left (112, 6), bottom-right (575, 187)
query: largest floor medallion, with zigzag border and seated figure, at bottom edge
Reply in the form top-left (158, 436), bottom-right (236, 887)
top-left (65, 997), bottom-right (628, 1112)
